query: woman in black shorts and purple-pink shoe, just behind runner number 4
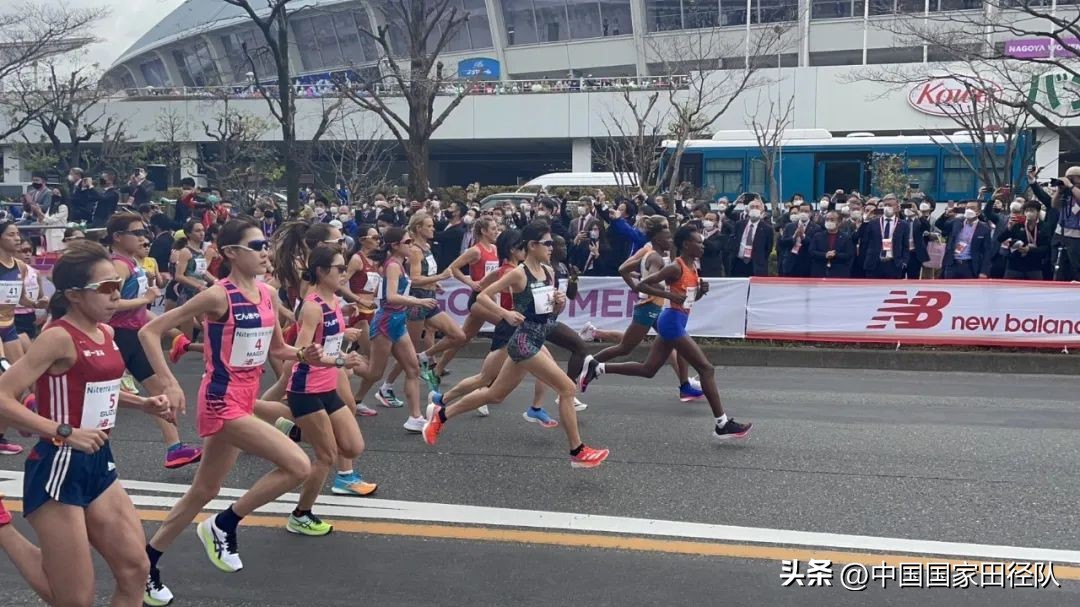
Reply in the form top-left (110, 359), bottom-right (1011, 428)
top-left (105, 213), bottom-right (202, 470)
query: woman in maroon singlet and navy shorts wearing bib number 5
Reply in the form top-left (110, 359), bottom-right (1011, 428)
top-left (0, 242), bottom-right (174, 606)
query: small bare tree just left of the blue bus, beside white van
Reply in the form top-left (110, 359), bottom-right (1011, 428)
top-left (598, 89), bottom-right (670, 194)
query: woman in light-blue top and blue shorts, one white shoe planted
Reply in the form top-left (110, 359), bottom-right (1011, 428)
top-left (356, 228), bottom-right (438, 433)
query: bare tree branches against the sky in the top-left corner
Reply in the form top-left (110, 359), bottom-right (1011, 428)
top-left (0, 1), bottom-right (108, 140)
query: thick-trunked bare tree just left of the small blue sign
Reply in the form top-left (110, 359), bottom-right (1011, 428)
top-left (341, 0), bottom-right (469, 198)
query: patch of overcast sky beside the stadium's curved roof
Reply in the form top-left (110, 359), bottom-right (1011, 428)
top-left (67, 0), bottom-right (184, 70)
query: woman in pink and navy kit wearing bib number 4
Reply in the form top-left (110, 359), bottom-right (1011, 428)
top-left (139, 219), bottom-right (324, 605)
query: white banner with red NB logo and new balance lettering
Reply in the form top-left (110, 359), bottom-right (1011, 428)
top-left (746, 278), bottom-right (1080, 347)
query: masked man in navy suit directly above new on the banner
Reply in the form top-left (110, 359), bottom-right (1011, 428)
top-left (936, 201), bottom-right (997, 280)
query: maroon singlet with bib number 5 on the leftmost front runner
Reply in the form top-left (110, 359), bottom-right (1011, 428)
top-left (35, 319), bottom-right (124, 431)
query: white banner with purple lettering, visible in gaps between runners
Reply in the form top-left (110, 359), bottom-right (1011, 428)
top-left (429, 276), bottom-right (750, 337)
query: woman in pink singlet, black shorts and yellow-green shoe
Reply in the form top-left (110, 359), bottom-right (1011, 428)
top-left (286, 245), bottom-right (378, 536)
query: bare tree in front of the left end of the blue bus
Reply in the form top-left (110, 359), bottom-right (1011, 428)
top-left (650, 29), bottom-right (786, 191)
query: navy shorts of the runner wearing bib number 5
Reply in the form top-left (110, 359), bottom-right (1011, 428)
top-left (23, 441), bottom-right (117, 516)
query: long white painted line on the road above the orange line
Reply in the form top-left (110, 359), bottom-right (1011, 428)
top-left (0, 470), bottom-right (1080, 564)
